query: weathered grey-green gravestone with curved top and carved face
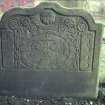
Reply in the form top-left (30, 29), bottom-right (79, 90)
top-left (0, 3), bottom-right (102, 98)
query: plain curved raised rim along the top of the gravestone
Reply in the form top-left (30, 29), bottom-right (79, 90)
top-left (1, 2), bottom-right (95, 29)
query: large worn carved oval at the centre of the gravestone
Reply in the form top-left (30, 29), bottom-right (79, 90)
top-left (20, 32), bottom-right (69, 69)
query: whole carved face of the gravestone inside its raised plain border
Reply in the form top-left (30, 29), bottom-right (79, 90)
top-left (2, 9), bottom-right (95, 71)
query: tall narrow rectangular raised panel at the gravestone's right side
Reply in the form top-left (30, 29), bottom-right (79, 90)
top-left (80, 31), bottom-right (94, 71)
